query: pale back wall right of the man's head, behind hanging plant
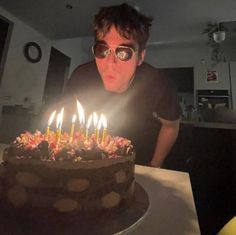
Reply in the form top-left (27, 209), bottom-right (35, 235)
top-left (146, 38), bottom-right (236, 68)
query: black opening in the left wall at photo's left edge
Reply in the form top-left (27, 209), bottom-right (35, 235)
top-left (0, 15), bottom-right (13, 84)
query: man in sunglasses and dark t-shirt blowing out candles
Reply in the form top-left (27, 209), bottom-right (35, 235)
top-left (62, 4), bottom-right (181, 167)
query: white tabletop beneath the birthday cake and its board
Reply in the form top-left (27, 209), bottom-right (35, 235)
top-left (0, 144), bottom-right (200, 235)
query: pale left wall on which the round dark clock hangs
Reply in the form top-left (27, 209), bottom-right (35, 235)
top-left (0, 8), bottom-right (50, 112)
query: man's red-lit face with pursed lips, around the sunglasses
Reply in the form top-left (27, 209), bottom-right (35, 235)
top-left (95, 27), bottom-right (145, 93)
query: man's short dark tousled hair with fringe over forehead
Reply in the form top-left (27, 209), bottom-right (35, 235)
top-left (94, 3), bottom-right (153, 52)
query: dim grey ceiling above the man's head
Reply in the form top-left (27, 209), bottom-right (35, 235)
top-left (0, 0), bottom-right (236, 45)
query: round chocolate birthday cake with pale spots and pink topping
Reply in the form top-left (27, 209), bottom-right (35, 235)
top-left (0, 131), bottom-right (135, 224)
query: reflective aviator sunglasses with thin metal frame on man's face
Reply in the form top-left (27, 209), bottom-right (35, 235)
top-left (92, 43), bottom-right (135, 61)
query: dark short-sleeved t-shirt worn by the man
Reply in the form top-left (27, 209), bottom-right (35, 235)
top-left (64, 61), bottom-right (181, 165)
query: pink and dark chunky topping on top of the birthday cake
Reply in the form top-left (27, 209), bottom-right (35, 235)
top-left (7, 130), bottom-right (133, 162)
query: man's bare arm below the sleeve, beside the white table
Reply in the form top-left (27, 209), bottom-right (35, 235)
top-left (150, 118), bottom-right (179, 167)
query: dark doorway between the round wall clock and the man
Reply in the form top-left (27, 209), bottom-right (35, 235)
top-left (43, 47), bottom-right (71, 111)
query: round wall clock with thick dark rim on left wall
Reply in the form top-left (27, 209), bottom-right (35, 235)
top-left (24, 42), bottom-right (42, 63)
